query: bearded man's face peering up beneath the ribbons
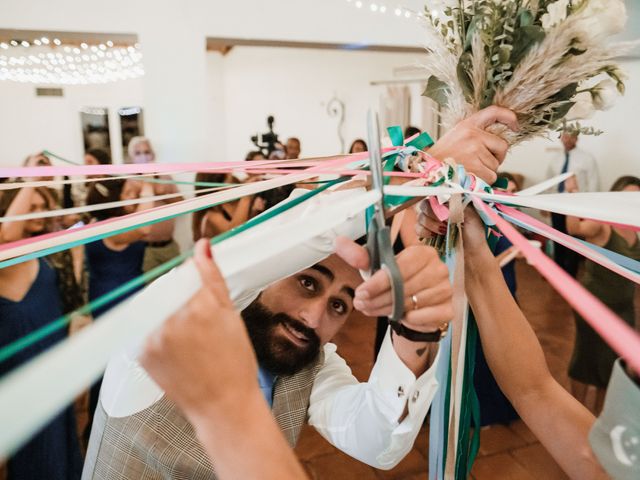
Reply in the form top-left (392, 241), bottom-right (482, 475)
top-left (242, 255), bottom-right (362, 375)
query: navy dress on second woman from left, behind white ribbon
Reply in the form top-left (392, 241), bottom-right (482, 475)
top-left (84, 240), bottom-right (146, 442)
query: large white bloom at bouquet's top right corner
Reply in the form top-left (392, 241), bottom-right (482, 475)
top-left (577, 0), bottom-right (627, 45)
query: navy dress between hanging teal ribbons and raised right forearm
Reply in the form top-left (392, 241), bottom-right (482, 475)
top-left (473, 236), bottom-right (518, 426)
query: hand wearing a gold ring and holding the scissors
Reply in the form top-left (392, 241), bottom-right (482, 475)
top-left (336, 237), bottom-right (453, 332)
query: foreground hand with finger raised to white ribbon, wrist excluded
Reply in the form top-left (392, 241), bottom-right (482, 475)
top-left (140, 239), bottom-right (258, 420)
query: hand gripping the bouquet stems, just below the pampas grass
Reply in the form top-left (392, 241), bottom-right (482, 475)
top-left (429, 105), bottom-right (520, 185)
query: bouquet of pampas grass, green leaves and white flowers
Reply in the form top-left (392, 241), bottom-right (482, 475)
top-left (424, 0), bottom-right (636, 145)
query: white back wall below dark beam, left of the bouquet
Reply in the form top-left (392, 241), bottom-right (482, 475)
top-left (218, 47), bottom-right (428, 160)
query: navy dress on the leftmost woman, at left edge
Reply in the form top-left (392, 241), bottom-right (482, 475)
top-left (0, 259), bottom-right (82, 480)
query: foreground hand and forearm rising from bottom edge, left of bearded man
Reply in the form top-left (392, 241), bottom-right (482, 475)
top-left (141, 240), bottom-right (307, 480)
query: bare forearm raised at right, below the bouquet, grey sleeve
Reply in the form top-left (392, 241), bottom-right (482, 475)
top-left (463, 210), bottom-right (607, 480)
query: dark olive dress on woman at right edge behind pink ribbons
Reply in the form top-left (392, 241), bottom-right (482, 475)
top-left (569, 229), bottom-right (640, 388)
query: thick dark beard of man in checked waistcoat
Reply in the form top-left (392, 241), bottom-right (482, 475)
top-left (242, 298), bottom-right (320, 375)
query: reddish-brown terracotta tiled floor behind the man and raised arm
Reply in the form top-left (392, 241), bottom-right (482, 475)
top-left (296, 261), bottom-right (574, 480)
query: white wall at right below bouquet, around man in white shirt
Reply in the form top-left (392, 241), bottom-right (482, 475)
top-left (503, 60), bottom-right (640, 190)
